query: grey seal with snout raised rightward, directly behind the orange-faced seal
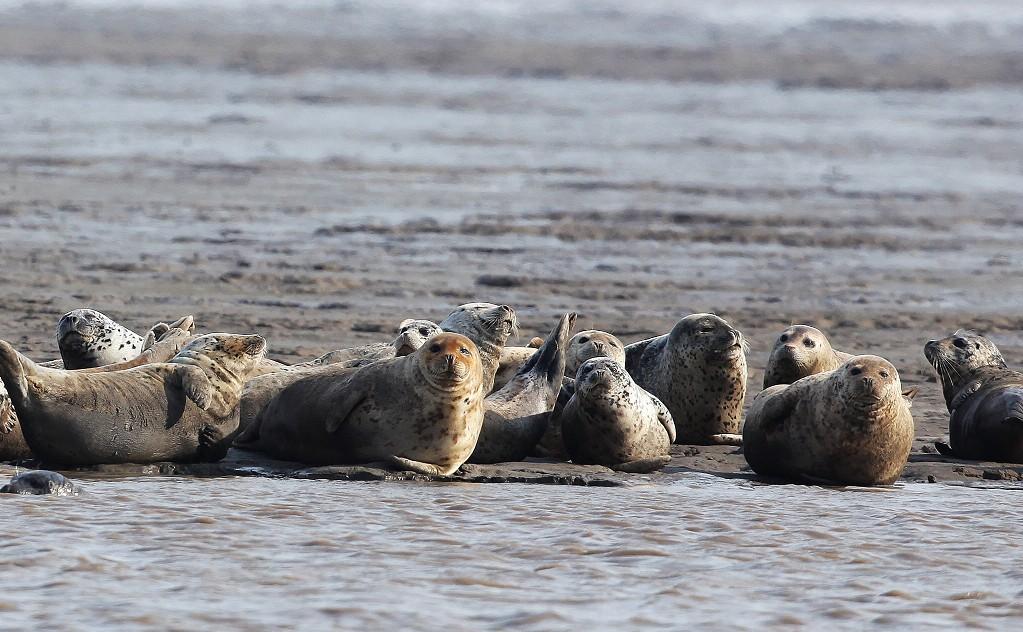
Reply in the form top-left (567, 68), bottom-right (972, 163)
top-left (440, 303), bottom-right (519, 393)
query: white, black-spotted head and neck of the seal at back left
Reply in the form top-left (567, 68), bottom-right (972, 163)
top-left (57, 309), bottom-right (143, 369)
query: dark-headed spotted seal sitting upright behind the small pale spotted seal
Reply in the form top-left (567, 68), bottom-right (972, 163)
top-left (625, 314), bottom-right (747, 445)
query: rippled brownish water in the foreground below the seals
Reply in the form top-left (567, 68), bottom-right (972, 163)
top-left (0, 475), bottom-right (1023, 630)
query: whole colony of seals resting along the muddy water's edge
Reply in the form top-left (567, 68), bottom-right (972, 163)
top-left (0, 302), bottom-right (1023, 486)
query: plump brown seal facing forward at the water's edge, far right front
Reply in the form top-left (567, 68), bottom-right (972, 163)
top-left (743, 356), bottom-right (915, 485)
